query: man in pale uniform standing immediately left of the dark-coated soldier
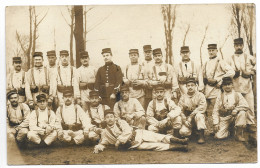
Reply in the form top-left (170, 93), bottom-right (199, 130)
top-left (74, 51), bottom-right (97, 111)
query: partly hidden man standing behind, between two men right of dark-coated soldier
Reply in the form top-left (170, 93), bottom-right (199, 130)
top-left (142, 45), bottom-right (154, 110)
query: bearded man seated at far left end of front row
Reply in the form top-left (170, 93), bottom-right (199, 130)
top-left (7, 89), bottom-right (30, 144)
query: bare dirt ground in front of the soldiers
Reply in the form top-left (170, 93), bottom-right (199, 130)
top-left (7, 137), bottom-right (257, 165)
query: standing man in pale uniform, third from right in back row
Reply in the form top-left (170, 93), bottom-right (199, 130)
top-left (175, 46), bottom-right (204, 94)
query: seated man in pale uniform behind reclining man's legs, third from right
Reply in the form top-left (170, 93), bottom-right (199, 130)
top-left (146, 85), bottom-right (182, 137)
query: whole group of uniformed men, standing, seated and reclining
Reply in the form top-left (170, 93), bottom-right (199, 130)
top-left (7, 38), bottom-right (256, 153)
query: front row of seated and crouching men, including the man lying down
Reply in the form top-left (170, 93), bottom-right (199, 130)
top-left (7, 77), bottom-right (250, 153)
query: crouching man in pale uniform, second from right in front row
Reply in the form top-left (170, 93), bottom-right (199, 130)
top-left (178, 78), bottom-right (207, 144)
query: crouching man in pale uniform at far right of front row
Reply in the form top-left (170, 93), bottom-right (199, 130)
top-left (212, 77), bottom-right (250, 141)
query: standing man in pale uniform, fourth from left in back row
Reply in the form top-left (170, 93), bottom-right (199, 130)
top-left (57, 50), bottom-right (75, 105)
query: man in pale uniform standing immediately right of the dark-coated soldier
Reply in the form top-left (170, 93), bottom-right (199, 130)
top-left (123, 49), bottom-right (146, 107)
